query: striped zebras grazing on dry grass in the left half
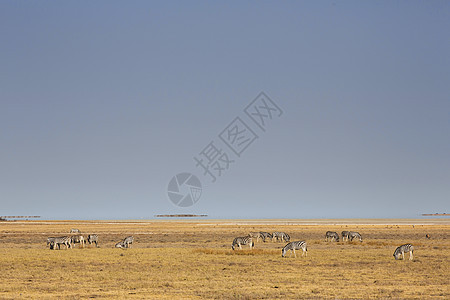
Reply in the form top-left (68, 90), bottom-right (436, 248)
top-left (47, 228), bottom-right (134, 250)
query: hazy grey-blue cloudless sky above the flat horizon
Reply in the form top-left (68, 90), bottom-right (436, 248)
top-left (0, 1), bottom-right (450, 219)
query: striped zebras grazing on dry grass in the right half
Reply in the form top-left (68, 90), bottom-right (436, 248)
top-left (231, 231), bottom-right (414, 260)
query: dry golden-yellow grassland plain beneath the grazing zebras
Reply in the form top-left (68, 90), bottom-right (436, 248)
top-left (0, 219), bottom-right (450, 299)
